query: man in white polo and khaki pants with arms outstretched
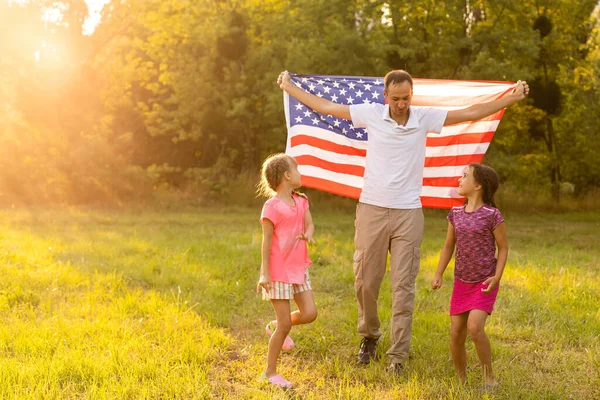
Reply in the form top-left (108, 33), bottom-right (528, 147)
top-left (277, 70), bottom-right (529, 373)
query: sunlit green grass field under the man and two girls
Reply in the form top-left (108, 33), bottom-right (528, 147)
top-left (0, 208), bottom-right (600, 399)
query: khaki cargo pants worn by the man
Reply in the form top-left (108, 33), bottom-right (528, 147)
top-left (354, 203), bottom-right (424, 363)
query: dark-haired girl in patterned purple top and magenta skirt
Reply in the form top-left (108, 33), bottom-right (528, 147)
top-left (431, 164), bottom-right (508, 388)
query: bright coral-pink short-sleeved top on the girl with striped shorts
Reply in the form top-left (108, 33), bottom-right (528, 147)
top-left (260, 194), bottom-right (312, 284)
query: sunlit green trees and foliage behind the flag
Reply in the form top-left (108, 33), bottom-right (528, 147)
top-left (0, 0), bottom-right (600, 204)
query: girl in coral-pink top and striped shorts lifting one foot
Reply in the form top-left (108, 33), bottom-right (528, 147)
top-left (256, 154), bottom-right (317, 389)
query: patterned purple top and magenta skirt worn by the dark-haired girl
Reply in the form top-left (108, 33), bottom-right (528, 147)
top-left (448, 205), bottom-right (504, 315)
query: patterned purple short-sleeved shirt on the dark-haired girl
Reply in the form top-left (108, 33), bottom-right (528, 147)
top-left (448, 205), bottom-right (504, 283)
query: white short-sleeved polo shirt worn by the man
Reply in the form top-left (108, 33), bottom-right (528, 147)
top-left (350, 103), bottom-right (447, 209)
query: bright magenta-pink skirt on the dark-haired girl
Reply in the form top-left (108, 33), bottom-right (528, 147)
top-left (450, 278), bottom-right (500, 315)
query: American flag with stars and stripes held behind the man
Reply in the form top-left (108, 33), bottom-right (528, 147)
top-left (284, 74), bottom-right (515, 208)
